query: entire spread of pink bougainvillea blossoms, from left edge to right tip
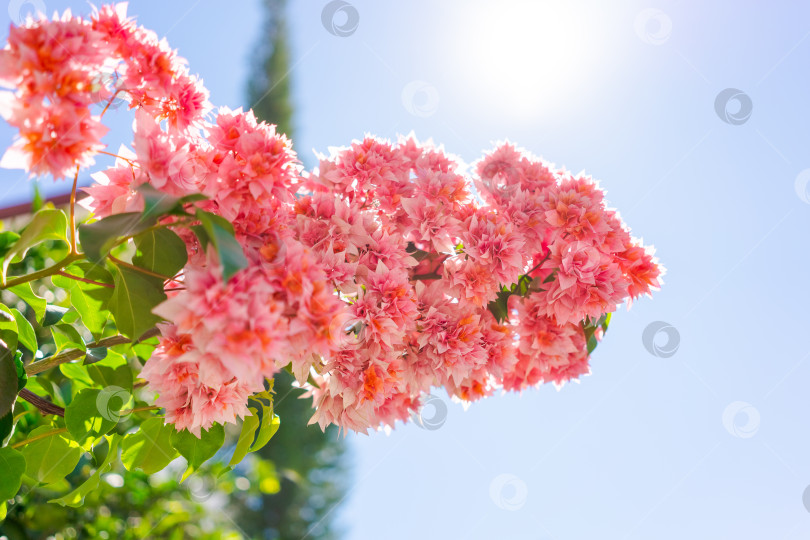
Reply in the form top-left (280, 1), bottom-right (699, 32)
top-left (0, 5), bottom-right (662, 435)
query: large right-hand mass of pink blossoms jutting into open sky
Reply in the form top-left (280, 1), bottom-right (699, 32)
top-left (296, 137), bottom-right (662, 431)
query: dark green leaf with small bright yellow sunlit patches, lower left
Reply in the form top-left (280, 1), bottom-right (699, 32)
top-left (65, 388), bottom-right (117, 444)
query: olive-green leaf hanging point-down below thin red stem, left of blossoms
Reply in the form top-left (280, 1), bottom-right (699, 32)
top-left (109, 266), bottom-right (166, 339)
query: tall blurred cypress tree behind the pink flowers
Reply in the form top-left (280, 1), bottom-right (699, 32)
top-left (240, 0), bottom-right (344, 540)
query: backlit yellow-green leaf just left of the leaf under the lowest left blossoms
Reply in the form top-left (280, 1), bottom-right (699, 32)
top-left (121, 416), bottom-right (178, 474)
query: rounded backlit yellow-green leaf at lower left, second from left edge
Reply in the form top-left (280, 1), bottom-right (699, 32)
top-left (21, 426), bottom-right (82, 484)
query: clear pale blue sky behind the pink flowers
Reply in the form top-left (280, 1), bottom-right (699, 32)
top-left (0, 0), bottom-right (810, 540)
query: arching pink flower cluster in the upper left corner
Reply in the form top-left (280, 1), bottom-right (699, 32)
top-left (0, 4), bottom-right (210, 178)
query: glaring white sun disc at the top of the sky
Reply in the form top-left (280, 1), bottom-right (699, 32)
top-left (455, 1), bottom-right (607, 118)
